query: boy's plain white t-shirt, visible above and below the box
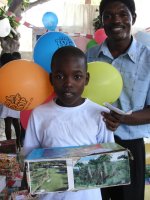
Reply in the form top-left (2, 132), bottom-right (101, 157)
top-left (23, 99), bottom-right (114, 200)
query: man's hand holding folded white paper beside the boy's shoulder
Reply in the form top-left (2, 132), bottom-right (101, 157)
top-left (102, 111), bottom-right (124, 131)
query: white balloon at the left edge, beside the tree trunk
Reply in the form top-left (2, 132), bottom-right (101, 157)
top-left (0, 18), bottom-right (11, 37)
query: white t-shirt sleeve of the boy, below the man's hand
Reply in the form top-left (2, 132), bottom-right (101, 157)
top-left (97, 115), bottom-right (115, 143)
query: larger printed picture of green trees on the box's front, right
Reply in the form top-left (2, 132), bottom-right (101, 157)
top-left (73, 152), bottom-right (130, 189)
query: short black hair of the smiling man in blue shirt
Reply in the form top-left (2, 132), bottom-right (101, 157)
top-left (99, 0), bottom-right (135, 17)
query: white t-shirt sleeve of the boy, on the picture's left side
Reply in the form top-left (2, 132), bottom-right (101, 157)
top-left (23, 112), bottom-right (40, 157)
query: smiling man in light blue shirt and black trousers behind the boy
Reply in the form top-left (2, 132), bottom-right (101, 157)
top-left (87, 0), bottom-right (150, 200)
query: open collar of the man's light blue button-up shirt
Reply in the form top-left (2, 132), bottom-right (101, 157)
top-left (97, 38), bottom-right (137, 63)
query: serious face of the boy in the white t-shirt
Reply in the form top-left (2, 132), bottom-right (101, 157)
top-left (50, 56), bottom-right (89, 107)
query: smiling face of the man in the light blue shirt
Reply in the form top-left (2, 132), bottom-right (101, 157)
top-left (102, 1), bottom-right (136, 41)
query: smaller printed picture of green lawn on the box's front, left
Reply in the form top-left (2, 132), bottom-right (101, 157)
top-left (29, 161), bottom-right (68, 194)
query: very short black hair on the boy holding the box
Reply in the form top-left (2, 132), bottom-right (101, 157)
top-left (51, 46), bottom-right (87, 71)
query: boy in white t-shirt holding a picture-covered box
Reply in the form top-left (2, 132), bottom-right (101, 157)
top-left (24, 46), bottom-right (114, 200)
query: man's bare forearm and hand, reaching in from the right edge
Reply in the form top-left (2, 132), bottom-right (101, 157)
top-left (102, 106), bottom-right (150, 131)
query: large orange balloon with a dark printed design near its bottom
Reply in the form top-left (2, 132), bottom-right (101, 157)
top-left (0, 60), bottom-right (53, 111)
